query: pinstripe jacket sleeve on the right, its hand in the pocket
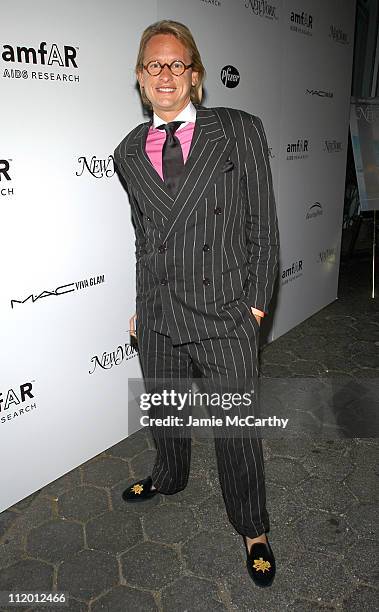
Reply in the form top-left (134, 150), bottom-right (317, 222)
top-left (244, 116), bottom-right (279, 312)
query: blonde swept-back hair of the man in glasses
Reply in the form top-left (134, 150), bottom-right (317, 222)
top-left (135, 19), bottom-right (205, 109)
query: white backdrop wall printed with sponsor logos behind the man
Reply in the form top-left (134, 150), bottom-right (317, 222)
top-left (0, 0), bottom-right (355, 511)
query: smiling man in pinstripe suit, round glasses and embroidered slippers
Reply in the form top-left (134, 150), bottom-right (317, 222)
top-left (115, 20), bottom-right (278, 586)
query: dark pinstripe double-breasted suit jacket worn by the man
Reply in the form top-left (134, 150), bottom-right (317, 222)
top-left (114, 105), bottom-right (278, 345)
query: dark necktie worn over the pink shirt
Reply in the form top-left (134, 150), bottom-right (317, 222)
top-left (158, 121), bottom-right (184, 197)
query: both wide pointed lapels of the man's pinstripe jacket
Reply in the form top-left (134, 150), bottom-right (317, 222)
top-left (121, 105), bottom-right (236, 234)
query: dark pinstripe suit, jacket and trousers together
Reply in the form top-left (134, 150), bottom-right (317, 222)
top-left (115, 105), bottom-right (278, 537)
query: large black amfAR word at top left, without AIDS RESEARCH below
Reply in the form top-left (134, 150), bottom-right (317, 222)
top-left (1, 42), bottom-right (78, 68)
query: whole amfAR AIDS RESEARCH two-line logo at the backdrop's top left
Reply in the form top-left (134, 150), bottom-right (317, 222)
top-left (0, 41), bottom-right (79, 83)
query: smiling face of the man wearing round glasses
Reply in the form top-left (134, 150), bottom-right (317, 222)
top-left (137, 34), bottom-right (198, 121)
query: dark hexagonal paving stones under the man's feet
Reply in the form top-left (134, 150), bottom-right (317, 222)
top-left (0, 261), bottom-right (379, 612)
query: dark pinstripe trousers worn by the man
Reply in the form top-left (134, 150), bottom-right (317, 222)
top-left (137, 309), bottom-right (269, 538)
